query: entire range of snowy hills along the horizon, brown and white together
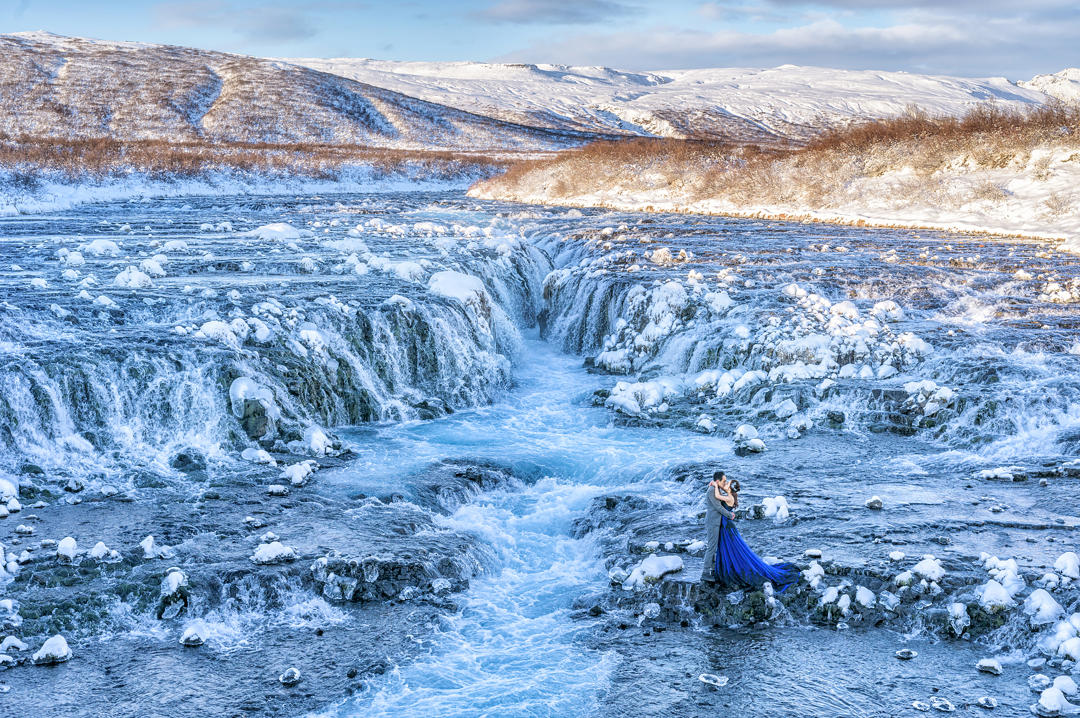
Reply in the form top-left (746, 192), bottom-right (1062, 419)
top-left (0, 32), bottom-right (1062, 151)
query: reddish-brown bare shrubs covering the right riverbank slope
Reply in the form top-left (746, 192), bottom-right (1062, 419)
top-left (480, 104), bottom-right (1080, 208)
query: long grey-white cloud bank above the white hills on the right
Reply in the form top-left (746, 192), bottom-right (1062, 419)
top-left (499, 11), bottom-right (1080, 78)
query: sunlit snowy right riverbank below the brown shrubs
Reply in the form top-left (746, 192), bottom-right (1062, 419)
top-left (470, 143), bottom-right (1080, 252)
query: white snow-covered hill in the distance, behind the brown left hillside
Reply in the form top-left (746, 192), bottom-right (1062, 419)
top-left (289, 58), bottom-right (1047, 139)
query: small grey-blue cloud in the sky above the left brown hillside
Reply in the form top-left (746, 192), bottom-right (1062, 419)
top-left (154, 0), bottom-right (319, 42)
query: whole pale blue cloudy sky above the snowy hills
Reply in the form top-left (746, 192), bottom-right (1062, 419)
top-left (0, 0), bottom-right (1080, 80)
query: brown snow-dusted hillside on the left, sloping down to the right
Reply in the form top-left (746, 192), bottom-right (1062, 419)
top-left (0, 32), bottom-right (581, 150)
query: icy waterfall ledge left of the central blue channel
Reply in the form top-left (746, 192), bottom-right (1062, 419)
top-left (0, 196), bottom-right (549, 488)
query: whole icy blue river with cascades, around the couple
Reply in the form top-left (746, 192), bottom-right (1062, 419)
top-left (0, 193), bottom-right (1080, 716)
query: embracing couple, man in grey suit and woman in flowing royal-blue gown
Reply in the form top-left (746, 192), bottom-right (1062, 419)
top-left (701, 471), bottom-right (799, 592)
